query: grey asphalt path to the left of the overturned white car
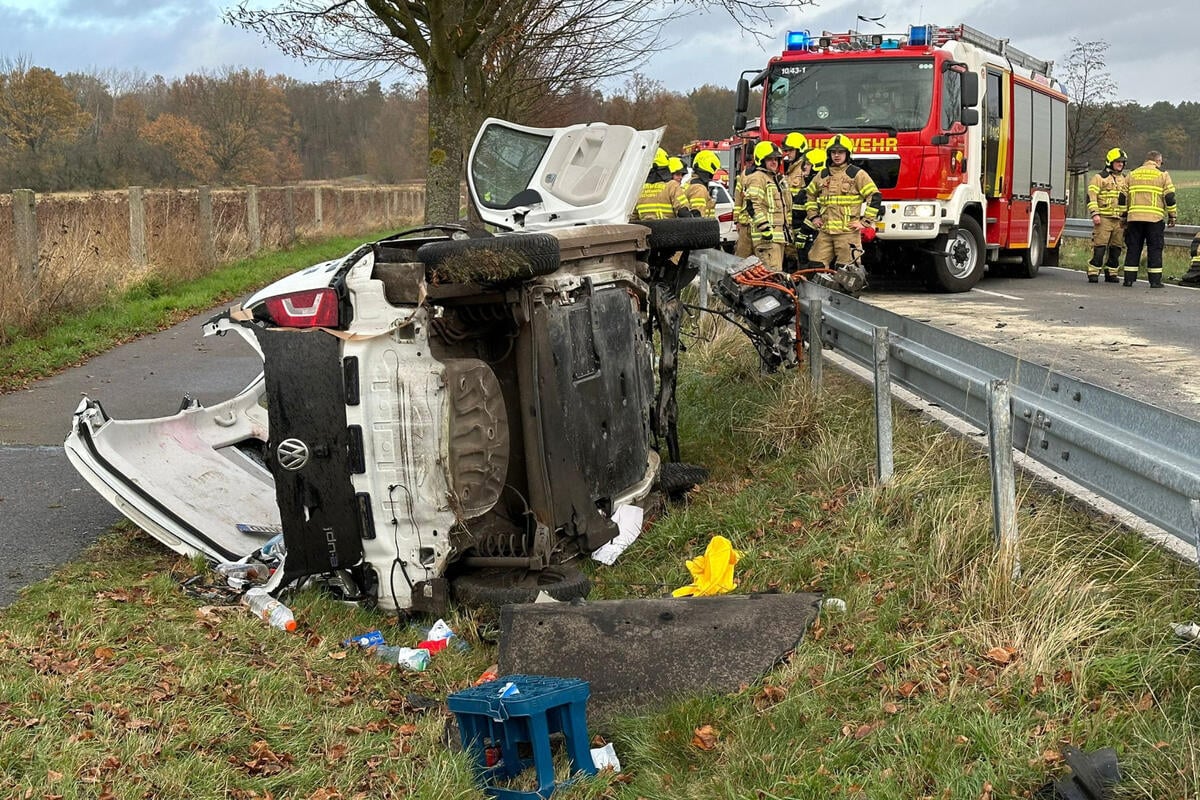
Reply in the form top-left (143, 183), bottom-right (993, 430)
top-left (0, 309), bottom-right (262, 607)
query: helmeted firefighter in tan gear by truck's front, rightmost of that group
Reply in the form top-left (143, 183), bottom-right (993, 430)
top-left (805, 133), bottom-right (883, 267)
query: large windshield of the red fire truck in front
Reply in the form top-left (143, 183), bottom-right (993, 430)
top-left (764, 59), bottom-right (934, 133)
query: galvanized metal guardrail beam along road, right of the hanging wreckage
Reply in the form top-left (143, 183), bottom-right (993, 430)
top-left (802, 283), bottom-right (1200, 546)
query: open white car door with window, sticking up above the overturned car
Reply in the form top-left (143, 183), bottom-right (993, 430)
top-left (467, 118), bottom-right (664, 230)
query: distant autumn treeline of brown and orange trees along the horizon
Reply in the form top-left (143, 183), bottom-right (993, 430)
top-left (0, 62), bottom-right (1200, 192)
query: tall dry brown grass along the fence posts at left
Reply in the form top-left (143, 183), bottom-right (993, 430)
top-left (0, 186), bottom-right (424, 344)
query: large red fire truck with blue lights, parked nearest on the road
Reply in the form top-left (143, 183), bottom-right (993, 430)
top-left (734, 25), bottom-right (1067, 291)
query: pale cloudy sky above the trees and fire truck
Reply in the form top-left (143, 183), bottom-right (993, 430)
top-left (0, 0), bottom-right (1200, 103)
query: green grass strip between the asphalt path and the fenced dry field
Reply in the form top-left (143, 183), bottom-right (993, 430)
top-left (0, 227), bottom-right (396, 393)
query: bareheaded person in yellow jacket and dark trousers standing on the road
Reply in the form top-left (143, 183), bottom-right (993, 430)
top-left (1124, 150), bottom-right (1176, 289)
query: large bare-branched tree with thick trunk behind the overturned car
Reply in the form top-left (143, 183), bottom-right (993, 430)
top-left (227, 0), bottom-right (812, 222)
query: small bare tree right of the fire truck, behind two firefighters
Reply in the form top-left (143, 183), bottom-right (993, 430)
top-left (1060, 36), bottom-right (1126, 168)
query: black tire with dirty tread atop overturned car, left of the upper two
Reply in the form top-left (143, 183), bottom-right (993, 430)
top-left (416, 234), bottom-right (562, 284)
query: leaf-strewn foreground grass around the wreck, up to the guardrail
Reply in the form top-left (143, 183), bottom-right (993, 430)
top-left (0, 316), bottom-right (1200, 800)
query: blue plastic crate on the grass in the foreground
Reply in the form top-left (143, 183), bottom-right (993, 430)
top-left (446, 675), bottom-right (596, 800)
